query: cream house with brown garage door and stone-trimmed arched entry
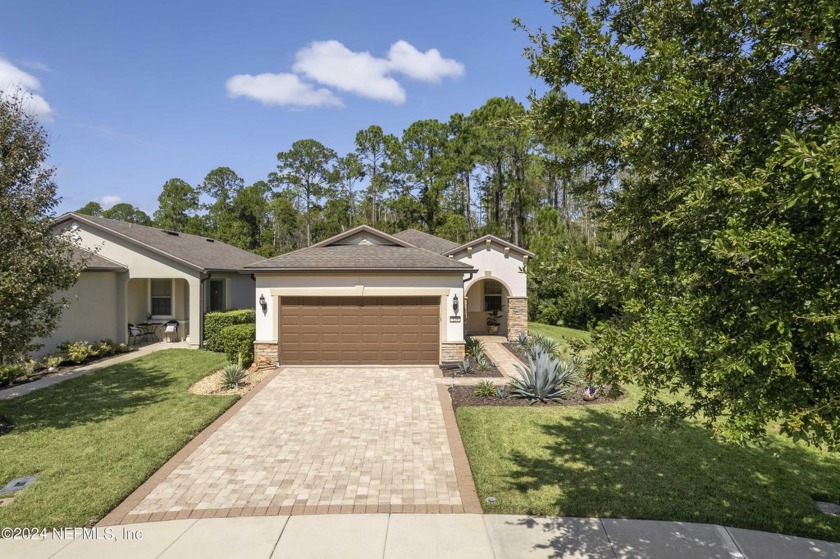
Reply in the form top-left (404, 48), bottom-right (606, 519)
top-left (242, 225), bottom-right (533, 365)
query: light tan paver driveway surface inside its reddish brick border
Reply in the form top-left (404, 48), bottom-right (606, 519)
top-left (117, 367), bottom-right (463, 522)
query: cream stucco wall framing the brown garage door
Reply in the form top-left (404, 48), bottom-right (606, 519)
top-left (251, 274), bottom-right (464, 343)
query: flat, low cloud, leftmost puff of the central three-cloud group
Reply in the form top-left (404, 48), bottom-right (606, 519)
top-left (225, 74), bottom-right (342, 107)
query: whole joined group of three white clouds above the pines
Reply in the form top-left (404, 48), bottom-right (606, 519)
top-left (226, 40), bottom-right (464, 107)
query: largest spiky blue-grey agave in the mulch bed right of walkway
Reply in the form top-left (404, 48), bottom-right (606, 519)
top-left (510, 349), bottom-right (577, 404)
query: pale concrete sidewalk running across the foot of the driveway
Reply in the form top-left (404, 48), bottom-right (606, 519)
top-left (0, 514), bottom-right (840, 559)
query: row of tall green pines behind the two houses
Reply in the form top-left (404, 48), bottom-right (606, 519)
top-left (72, 97), bottom-right (593, 256)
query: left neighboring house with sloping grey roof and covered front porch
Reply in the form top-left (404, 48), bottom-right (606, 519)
top-left (38, 213), bottom-right (261, 355)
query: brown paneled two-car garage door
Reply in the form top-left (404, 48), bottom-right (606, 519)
top-left (280, 297), bottom-right (440, 365)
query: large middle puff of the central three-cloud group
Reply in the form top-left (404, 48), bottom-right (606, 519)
top-left (292, 41), bottom-right (405, 103)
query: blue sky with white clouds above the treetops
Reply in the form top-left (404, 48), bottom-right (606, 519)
top-left (0, 0), bottom-right (554, 213)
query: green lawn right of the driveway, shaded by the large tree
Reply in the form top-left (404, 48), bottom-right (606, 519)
top-left (457, 388), bottom-right (840, 541)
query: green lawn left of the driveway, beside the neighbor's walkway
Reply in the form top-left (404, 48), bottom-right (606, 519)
top-left (0, 349), bottom-right (237, 527)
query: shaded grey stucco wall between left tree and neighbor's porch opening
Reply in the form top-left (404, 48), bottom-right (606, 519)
top-left (32, 272), bottom-right (125, 358)
